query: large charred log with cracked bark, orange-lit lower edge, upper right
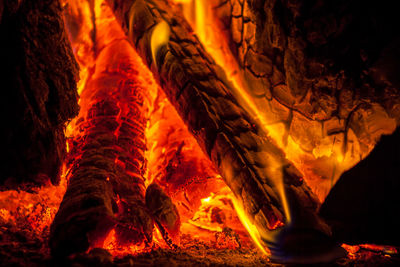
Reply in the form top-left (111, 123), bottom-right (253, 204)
top-left (209, 0), bottom-right (400, 199)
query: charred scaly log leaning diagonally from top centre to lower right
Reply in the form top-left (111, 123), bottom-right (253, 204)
top-left (108, 0), bottom-right (346, 259)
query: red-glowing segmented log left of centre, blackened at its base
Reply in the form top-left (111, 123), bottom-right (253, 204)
top-left (50, 37), bottom-right (153, 256)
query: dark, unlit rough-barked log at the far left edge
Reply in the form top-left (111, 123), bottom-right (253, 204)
top-left (0, 0), bottom-right (79, 189)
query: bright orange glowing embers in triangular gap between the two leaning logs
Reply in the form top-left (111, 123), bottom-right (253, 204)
top-left (146, 87), bottom-right (247, 247)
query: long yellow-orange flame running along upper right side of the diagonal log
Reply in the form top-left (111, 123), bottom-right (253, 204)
top-left (167, 0), bottom-right (373, 205)
